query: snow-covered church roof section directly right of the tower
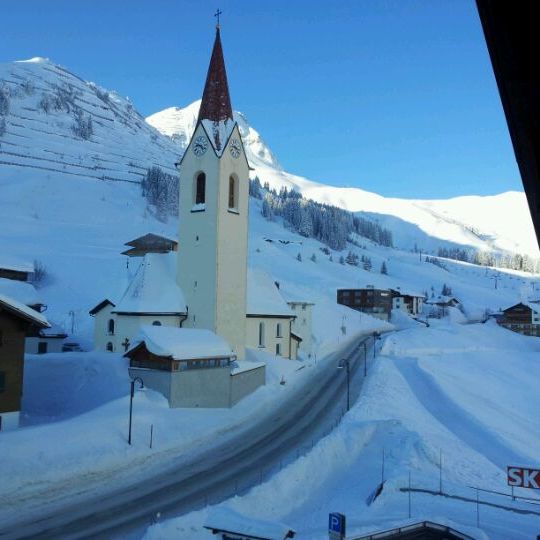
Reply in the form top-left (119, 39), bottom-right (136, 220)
top-left (246, 268), bottom-right (294, 317)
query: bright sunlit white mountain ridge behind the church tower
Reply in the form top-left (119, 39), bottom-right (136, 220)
top-left (146, 104), bottom-right (539, 257)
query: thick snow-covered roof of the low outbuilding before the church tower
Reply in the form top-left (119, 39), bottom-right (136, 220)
top-left (126, 326), bottom-right (234, 360)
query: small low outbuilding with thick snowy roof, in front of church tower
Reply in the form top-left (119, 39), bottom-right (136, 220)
top-left (125, 326), bottom-right (266, 408)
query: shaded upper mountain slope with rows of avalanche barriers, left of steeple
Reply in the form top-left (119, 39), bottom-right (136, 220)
top-left (0, 58), bottom-right (178, 182)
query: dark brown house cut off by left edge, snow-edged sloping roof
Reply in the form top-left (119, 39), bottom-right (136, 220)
top-left (0, 294), bottom-right (49, 431)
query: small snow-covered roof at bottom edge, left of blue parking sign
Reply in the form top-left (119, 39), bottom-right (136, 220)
top-left (204, 506), bottom-right (296, 540)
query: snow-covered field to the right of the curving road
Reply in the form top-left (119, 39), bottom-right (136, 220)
top-left (145, 322), bottom-right (540, 540)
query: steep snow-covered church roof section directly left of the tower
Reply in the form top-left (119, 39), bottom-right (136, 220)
top-left (113, 252), bottom-right (187, 314)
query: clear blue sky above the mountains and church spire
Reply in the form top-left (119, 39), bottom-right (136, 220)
top-left (0, 0), bottom-right (522, 198)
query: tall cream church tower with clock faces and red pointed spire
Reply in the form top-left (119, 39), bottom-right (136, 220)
top-left (177, 25), bottom-right (249, 359)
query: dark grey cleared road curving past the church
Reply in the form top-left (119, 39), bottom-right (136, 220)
top-left (0, 338), bottom-right (376, 538)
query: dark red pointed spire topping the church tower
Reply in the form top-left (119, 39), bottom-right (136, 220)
top-left (199, 25), bottom-right (233, 122)
